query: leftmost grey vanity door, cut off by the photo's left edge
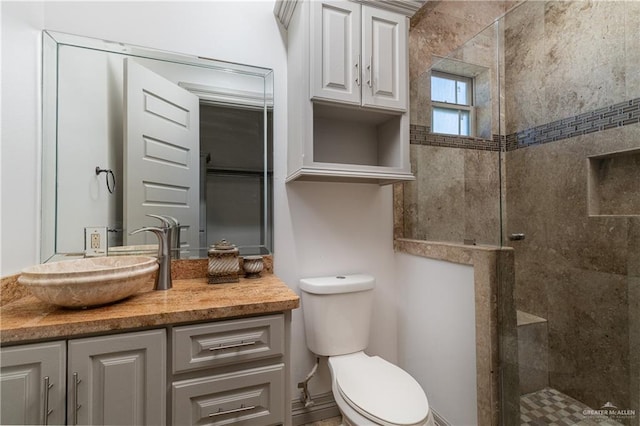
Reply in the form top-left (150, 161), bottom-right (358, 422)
top-left (0, 342), bottom-right (66, 425)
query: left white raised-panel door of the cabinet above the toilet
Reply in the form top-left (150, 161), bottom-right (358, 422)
top-left (310, 1), bottom-right (361, 105)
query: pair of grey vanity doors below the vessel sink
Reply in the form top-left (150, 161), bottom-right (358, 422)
top-left (0, 330), bottom-right (166, 425)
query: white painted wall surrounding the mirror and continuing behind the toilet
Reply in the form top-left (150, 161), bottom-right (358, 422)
top-left (0, 0), bottom-right (397, 400)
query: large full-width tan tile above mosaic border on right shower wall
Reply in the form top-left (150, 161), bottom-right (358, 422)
top-left (543, 1), bottom-right (626, 121)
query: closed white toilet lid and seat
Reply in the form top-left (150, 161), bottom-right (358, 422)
top-left (329, 352), bottom-right (429, 426)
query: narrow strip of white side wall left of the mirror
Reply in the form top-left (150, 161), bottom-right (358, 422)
top-left (0, 2), bottom-right (44, 276)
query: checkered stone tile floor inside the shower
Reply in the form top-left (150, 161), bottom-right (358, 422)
top-left (520, 388), bottom-right (622, 426)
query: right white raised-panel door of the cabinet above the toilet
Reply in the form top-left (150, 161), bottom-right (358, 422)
top-left (362, 6), bottom-right (408, 111)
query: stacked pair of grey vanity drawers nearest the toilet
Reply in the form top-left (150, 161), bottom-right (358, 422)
top-left (171, 314), bottom-right (284, 426)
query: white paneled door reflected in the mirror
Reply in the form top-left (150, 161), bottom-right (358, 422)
top-left (123, 58), bottom-right (200, 248)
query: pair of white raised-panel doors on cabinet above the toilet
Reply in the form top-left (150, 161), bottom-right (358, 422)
top-left (310, 1), bottom-right (408, 112)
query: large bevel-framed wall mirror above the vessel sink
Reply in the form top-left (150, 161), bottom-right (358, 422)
top-left (41, 31), bottom-right (273, 262)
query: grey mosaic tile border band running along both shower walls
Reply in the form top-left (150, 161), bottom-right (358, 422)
top-left (409, 98), bottom-right (640, 151)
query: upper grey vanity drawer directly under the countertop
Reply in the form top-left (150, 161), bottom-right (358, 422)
top-left (173, 315), bottom-right (284, 373)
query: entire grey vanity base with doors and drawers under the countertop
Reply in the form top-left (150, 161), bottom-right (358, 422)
top-left (0, 313), bottom-right (291, 426)
